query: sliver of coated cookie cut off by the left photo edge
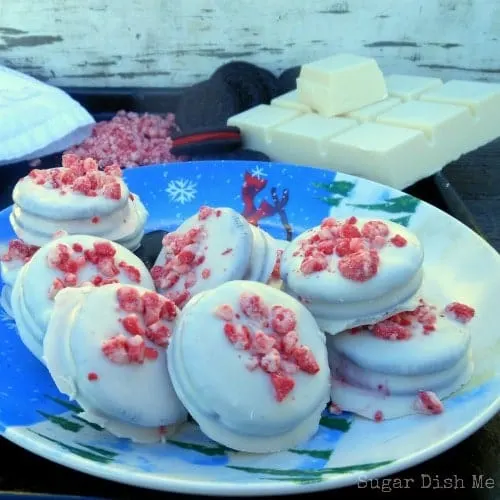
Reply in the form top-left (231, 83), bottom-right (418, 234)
top-left (0, 240), bottom-right (39, 317)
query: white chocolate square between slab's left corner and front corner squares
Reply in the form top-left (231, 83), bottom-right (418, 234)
top-left (271, 114), bottom-right (357, 166)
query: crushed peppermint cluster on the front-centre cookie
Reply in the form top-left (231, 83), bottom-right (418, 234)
top-left (214, 292), bottom-right (320, 402)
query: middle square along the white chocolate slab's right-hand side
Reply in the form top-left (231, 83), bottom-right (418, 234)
top-left (376, 101), bottom-right (473, 159)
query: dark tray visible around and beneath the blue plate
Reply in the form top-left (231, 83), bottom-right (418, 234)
top-left (0, 88), bottom-right (492, 500)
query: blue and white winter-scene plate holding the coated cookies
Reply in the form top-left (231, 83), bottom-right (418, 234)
top-left (0, 161), bottom-right (500, 495)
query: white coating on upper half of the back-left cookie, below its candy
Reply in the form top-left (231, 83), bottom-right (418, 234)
top-left (12, 167), bottom-right (129, 220)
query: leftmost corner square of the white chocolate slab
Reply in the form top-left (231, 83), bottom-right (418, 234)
top-left (227, 104), bottom-right (301, 154)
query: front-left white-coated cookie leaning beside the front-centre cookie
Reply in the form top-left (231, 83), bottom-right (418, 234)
top-left (43, 284), bottom-right (187, 442)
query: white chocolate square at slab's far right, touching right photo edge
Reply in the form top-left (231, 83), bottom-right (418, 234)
top-left (420, 80), bottom-right (500, 151)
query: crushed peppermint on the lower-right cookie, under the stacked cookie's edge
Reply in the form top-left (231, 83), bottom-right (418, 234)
top-left (368, 299), bottom-right (437, 340)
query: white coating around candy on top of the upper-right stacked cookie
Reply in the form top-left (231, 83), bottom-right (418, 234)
top-left (281, 219), bottom-right (424, 304)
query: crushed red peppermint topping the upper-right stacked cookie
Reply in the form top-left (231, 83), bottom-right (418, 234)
top-left (294, 217), bottom-right (407, 283)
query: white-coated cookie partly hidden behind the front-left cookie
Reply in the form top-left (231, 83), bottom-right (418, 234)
top-left (11, 235), bottom-right (154, 359)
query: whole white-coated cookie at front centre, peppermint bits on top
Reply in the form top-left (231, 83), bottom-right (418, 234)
top-left (167, 281), bottom-right (330, 453)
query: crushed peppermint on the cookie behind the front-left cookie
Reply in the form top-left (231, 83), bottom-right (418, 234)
top-left (47, 241), bottom-right (141, 299)
